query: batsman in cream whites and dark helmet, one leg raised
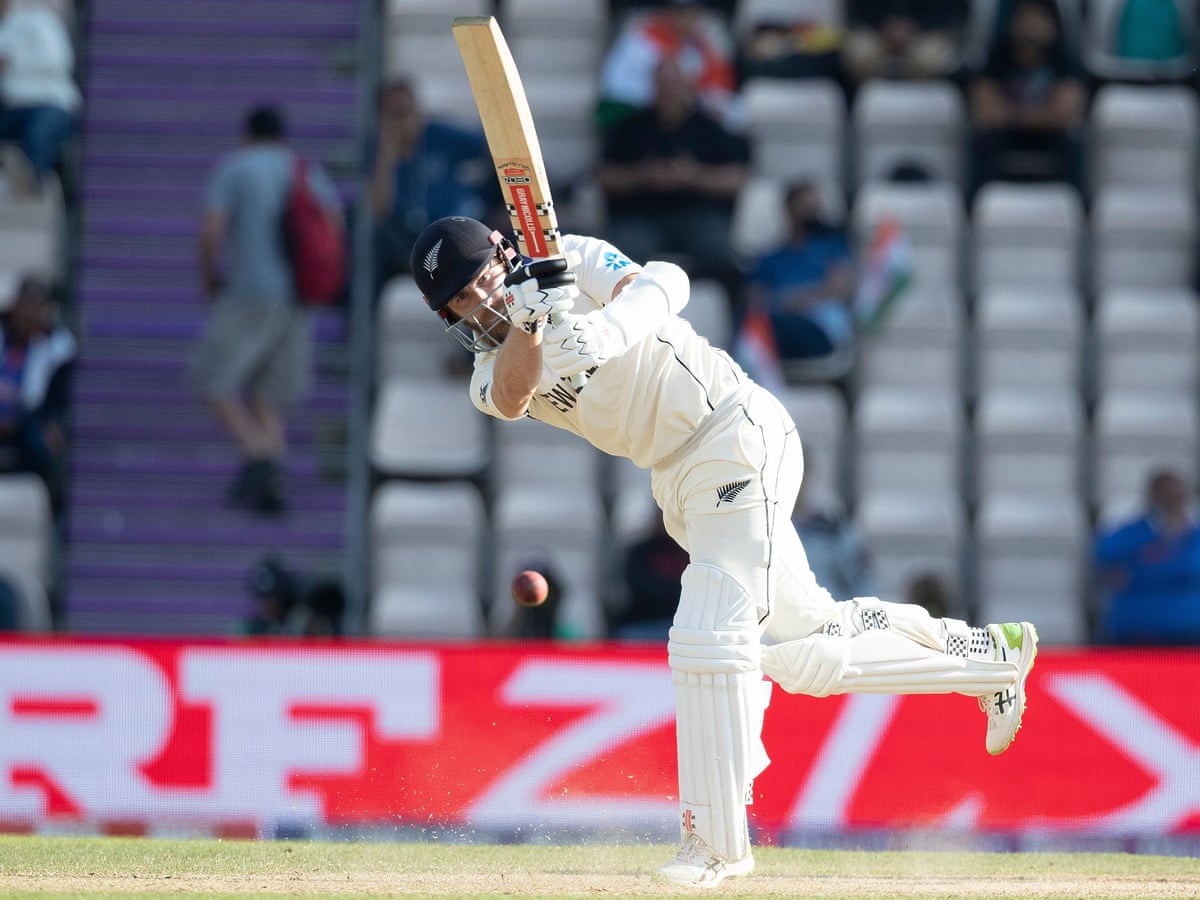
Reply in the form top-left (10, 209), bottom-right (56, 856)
top-left (412, 217), bottom-right (1038, 887)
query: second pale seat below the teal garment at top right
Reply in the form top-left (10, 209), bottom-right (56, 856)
top-left (1092, 185), bottom-right (1196, 292)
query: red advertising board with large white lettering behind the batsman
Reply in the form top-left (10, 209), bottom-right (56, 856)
top-left (0, 638), bottom-right (1200, 840)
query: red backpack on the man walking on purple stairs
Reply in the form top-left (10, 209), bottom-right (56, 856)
top-left (283, 156), bottom-right (347, 306)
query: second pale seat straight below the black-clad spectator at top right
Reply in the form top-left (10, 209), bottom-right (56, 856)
top-left (974, 286), bottom-right (1084, 400)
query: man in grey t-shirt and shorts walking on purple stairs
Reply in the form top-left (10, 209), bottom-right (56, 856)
top-left (192, 106), bottom-right (342, 514)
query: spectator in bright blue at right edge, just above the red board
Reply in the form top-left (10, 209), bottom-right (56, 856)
top-left (1094, 469), bottom-right (1200, 646)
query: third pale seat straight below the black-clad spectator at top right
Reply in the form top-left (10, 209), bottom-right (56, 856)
top-left (972, 386), bottom-right (1086, 499)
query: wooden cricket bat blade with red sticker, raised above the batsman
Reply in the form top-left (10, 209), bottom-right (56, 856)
top-left (451, 16), bottom-right (562, 257)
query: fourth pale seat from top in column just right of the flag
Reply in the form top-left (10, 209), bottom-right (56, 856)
top-left (853, 385), bottom-right (965, 497)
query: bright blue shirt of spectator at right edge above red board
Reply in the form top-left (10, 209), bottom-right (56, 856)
top-left (1096, 517), bottom-right (1200, 646)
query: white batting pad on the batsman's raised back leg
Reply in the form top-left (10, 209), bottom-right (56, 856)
top-left (762, 631), bottom-right (1016, 697)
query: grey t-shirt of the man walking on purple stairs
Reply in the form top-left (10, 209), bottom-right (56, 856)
top-left (204, 143), bottom-right (338, 302)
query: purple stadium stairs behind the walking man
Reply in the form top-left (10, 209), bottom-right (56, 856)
top-left (61, 0), bottom-right (360, 635)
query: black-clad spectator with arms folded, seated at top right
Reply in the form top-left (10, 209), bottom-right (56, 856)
top-left (968, 0), bottom-right (1086, 196)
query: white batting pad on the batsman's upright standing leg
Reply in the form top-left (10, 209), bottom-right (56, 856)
top-left (667, 564), bottom-right (770, 860)
